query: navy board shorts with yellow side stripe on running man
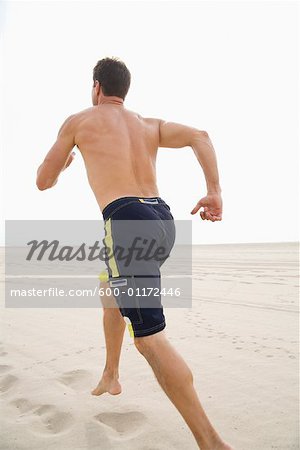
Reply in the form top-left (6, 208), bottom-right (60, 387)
top-left (102, 196), bottom-right (176, 337)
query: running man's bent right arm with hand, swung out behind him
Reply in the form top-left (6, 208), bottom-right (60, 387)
top-left (159, 120), bottom-right (222, 221)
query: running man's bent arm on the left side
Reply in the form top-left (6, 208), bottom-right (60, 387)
top-left (36, 115), bottom-right (76, 191)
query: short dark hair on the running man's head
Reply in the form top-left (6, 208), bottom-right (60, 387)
top-left (93, 58), bottom-right (131, 100)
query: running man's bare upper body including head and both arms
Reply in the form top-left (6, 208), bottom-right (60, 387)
top-left (36, 58), bottom-right (222, 222)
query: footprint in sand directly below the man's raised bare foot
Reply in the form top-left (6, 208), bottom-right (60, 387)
top-left (94, 411), bottom-right (146, 438)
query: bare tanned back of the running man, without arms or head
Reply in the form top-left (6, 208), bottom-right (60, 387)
top-left (74, 103), bottom-right (160, 209)
